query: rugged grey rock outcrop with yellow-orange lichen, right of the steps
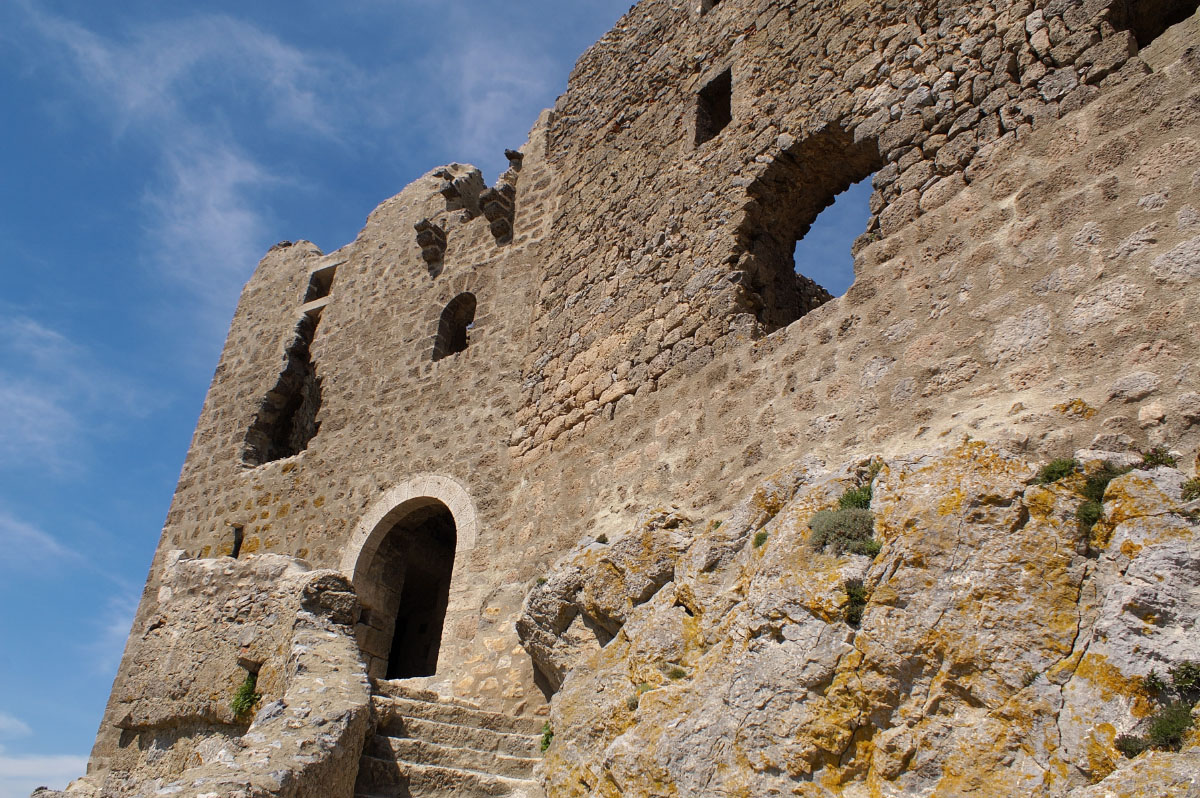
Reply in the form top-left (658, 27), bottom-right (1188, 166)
top-left (520, 442), bottom-right (1200, 798)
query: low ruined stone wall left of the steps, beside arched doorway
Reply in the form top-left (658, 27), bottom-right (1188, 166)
top-left (50, 553), bottom-right (371, 798)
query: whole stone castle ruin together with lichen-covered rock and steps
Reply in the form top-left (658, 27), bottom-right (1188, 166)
top-left (46, 0), bottom-right (1200, 798)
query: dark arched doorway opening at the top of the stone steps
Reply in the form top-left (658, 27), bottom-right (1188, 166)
top-left (360, 499), bottom-right (457, 679)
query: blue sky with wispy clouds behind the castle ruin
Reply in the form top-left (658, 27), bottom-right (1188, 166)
top-left (0, 0), bottom-right (865, 798)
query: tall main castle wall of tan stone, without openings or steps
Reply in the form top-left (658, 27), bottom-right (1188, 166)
top-left (84, 0), bottom-right (1200, 782)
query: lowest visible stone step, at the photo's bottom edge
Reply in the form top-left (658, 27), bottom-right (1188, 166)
top-left (355, 756), bottom-right (542, 798)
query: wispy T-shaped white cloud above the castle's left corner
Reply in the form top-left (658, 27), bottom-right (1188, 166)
top-left (11, 2), bottom-right (365, 329)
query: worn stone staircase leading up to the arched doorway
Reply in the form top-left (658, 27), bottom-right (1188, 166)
top-left (354, 682), bottom-right (545, 798)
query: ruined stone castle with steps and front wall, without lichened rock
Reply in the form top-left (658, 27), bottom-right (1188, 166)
top-left (51, 0), bottom-right (1200, 798)
